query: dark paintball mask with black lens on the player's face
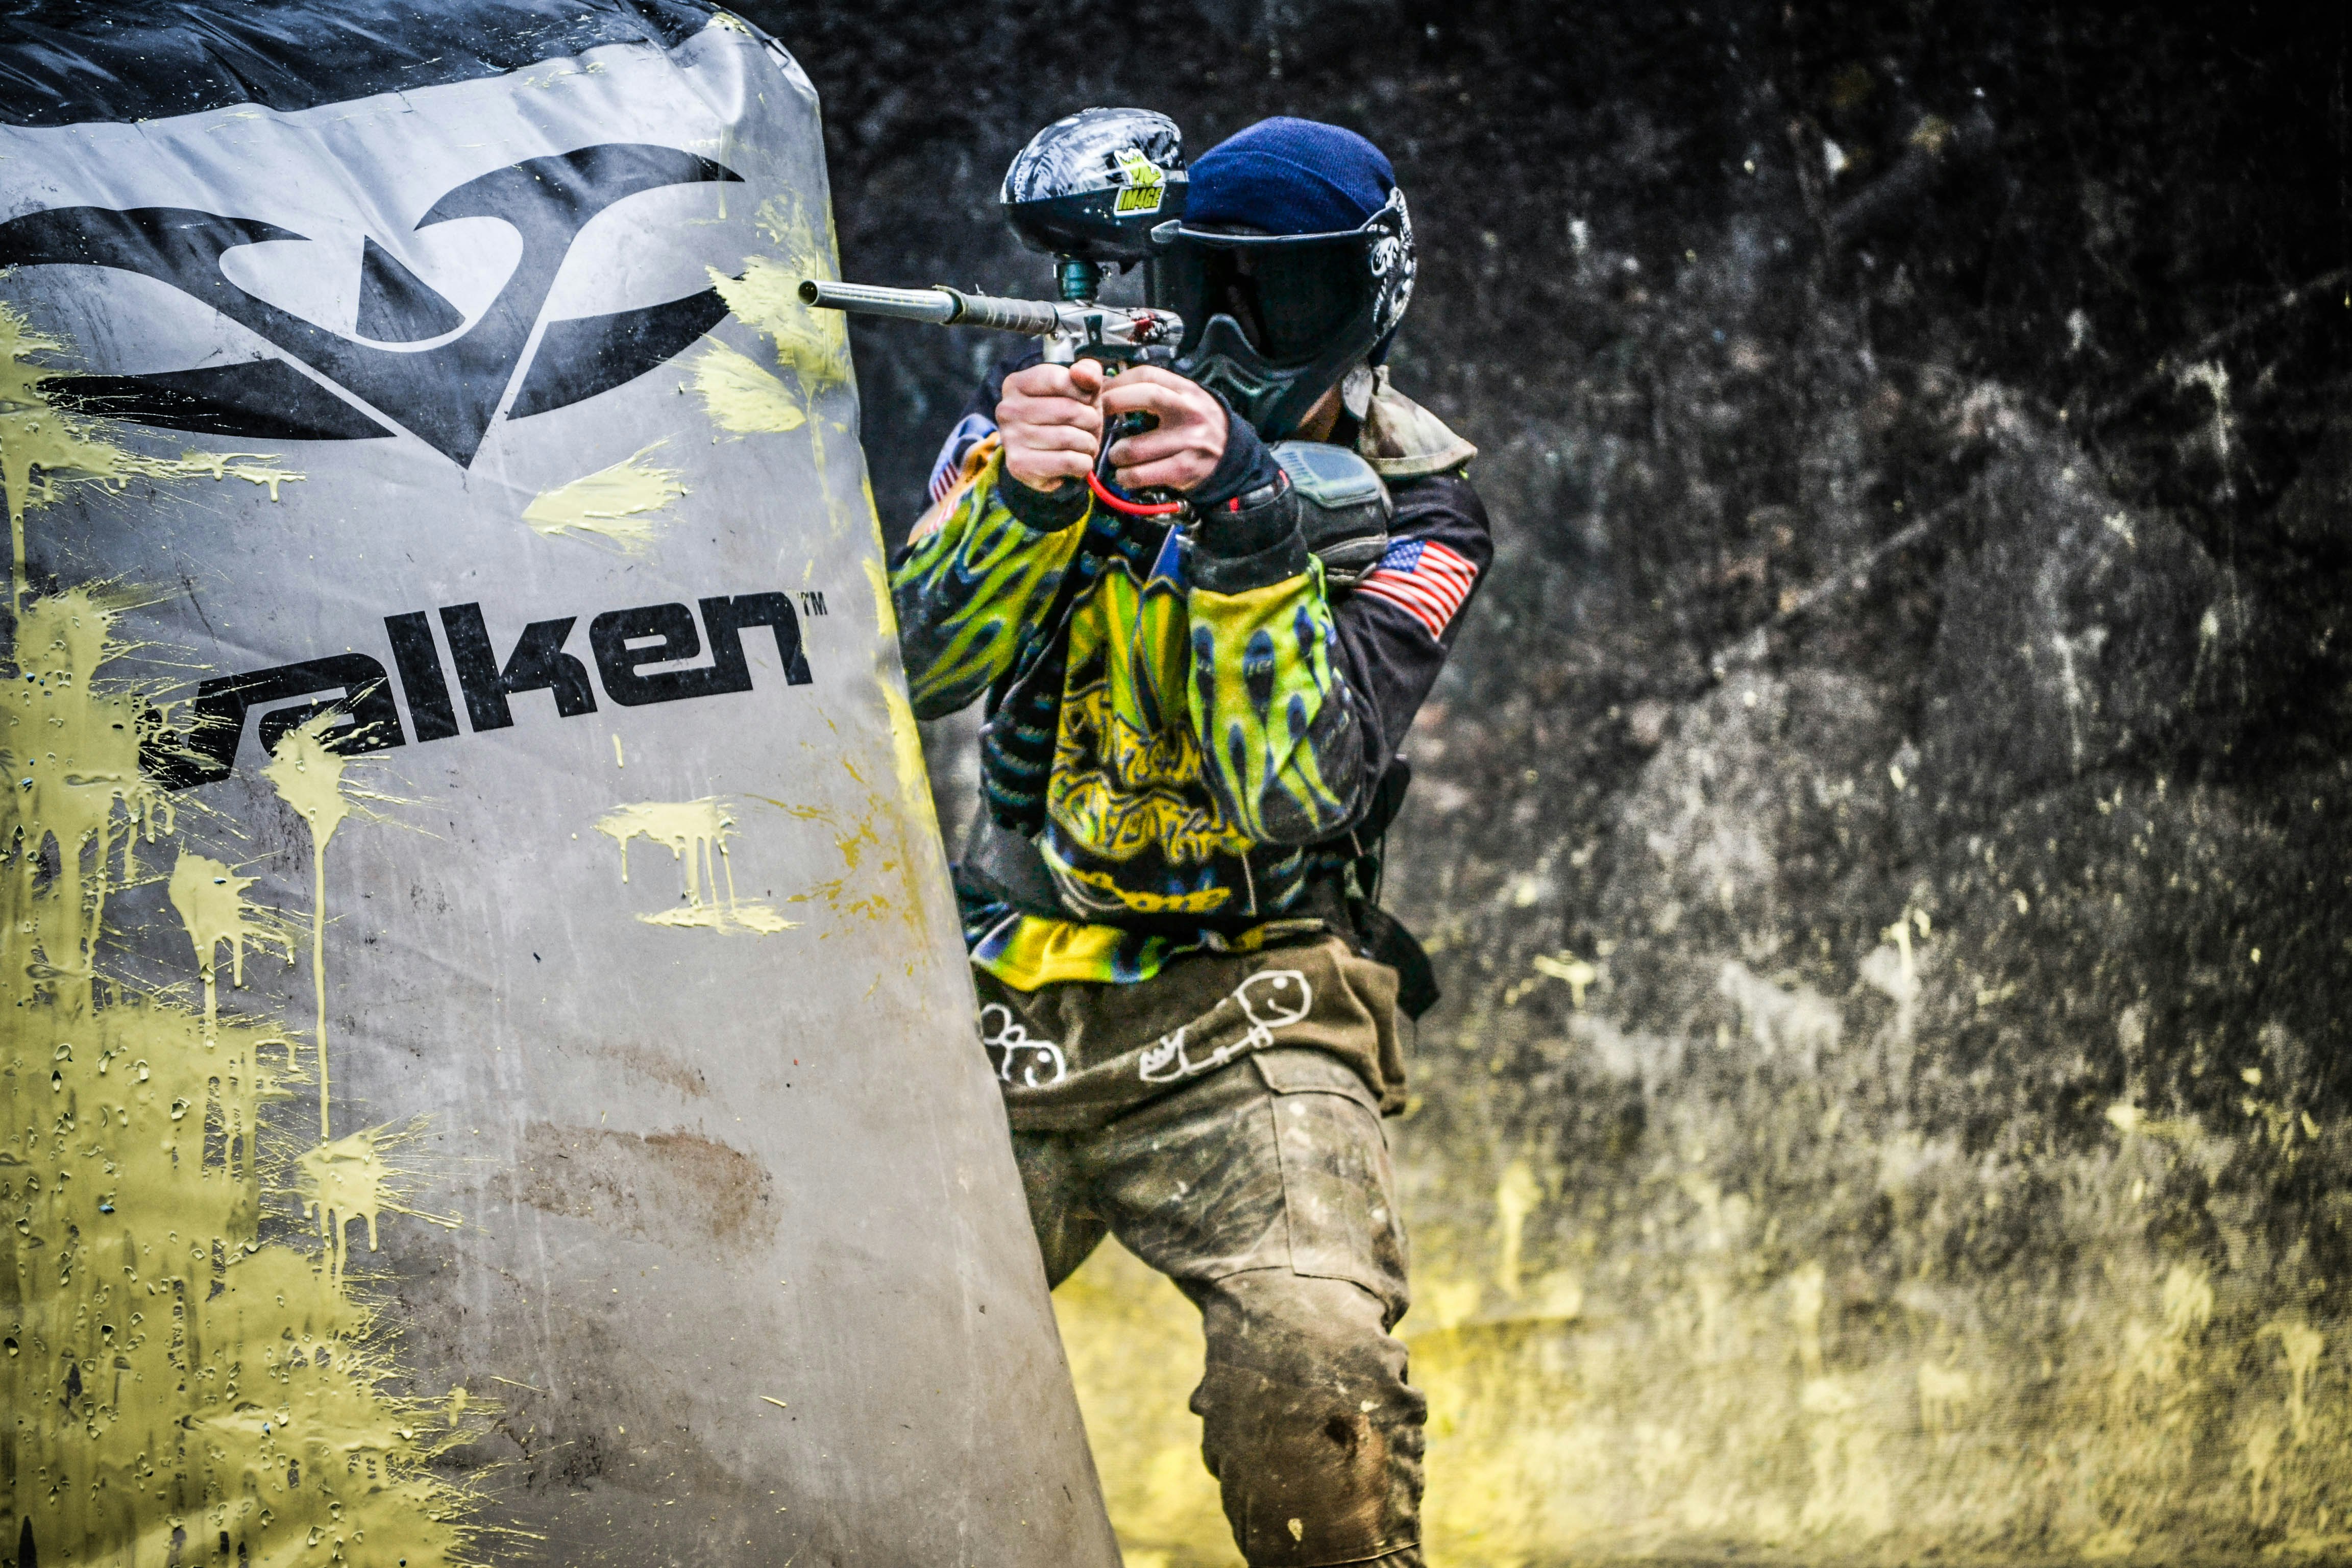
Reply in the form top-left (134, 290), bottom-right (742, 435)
top-left (1153, 188), bottom-right (1413, 439)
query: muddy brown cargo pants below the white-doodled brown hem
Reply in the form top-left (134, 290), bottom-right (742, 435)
top-left (1014, 1048), bottom-right (1428, 1568)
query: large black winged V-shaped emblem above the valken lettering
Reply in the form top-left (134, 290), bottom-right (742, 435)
top-left (0, 143), bottom-right (741, 465)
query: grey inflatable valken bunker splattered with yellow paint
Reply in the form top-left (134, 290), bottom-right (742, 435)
top-left (0, 0), bottom-right (1115, 1568)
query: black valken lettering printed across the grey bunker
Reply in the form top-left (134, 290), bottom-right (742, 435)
top-left (141, 593), bottom-right (825, 790)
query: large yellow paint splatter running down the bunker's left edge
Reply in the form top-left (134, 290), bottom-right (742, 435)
top-left (0, 308), bottom-right (482, 1568)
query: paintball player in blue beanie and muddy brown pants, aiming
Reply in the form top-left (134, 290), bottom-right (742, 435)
top-left (891, 110), bottom-right (1491, 1568)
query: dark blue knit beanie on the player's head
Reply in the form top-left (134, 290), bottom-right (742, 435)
top-left (1183, 115), bottom-right (1397, 235)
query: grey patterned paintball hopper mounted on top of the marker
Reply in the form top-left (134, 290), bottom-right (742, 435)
top-left (999, 108), bottom-right (1185, 301)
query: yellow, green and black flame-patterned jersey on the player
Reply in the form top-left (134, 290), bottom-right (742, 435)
top-left (891, 371), bottom-right (1491, 990)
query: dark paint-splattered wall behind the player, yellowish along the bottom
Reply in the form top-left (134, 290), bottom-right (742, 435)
top-left (746, 0), bottom-right (2352, 1563)
